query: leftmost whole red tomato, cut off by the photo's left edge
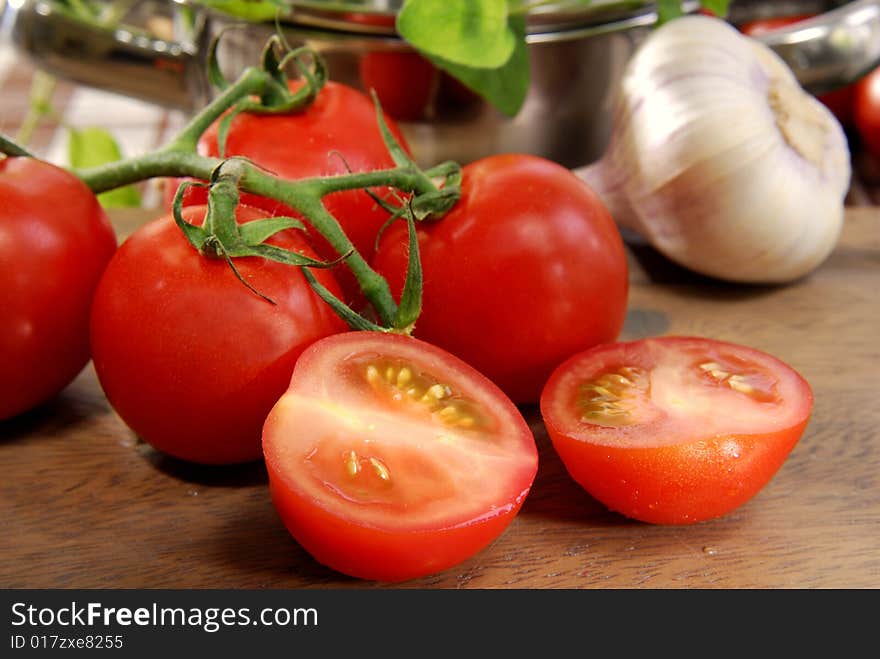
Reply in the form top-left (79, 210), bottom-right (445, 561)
top-left (0, 157), bottom-right (116, 420)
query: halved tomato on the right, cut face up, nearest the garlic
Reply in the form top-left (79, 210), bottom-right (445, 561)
top-left (541, 337), bottom-right (813, 524)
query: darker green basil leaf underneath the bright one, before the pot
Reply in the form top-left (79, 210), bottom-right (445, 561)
top-left (431, 16), bottom-right (530, 117)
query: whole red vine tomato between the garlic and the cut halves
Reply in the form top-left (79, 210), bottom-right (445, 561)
top-left (373, 155), bottom-right (628, 403)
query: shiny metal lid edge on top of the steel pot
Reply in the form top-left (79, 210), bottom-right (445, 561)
top-left (276, 0), bottom-right (697, 35)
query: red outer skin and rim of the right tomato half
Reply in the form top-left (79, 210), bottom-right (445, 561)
top-left (541, 337), bottom-right (813, 525)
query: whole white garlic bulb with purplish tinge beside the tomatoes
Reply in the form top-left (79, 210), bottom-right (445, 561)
top-left (577, 15), bottom-right (851, 283)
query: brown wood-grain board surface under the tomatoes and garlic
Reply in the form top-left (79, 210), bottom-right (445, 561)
top-left (0, 208), bottom-right (880, 589)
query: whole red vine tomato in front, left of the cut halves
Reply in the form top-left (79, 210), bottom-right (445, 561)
top-left (91, 206), bottom-right (346, 464)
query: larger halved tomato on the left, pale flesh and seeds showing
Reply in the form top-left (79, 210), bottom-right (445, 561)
top-left (263, 332), bottom-right (538, 582)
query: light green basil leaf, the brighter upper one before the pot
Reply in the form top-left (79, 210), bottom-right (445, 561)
top-left (397, 0), bottom-right (517, 69)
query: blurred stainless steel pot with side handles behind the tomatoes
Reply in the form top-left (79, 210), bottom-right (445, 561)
top-left (0, 0), bottom-right (880, 167)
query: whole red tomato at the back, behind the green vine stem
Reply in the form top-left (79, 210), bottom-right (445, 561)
top-left (171, 81), bottom-right (406, 301)
